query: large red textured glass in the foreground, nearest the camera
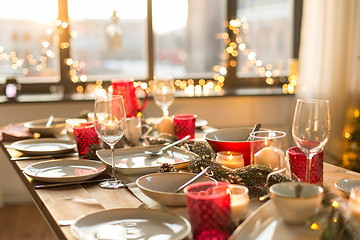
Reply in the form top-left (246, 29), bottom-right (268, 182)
top-left (184, 182), bottom-right (231, 240)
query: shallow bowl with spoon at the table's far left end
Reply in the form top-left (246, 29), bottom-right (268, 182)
top-left (24, 118), bottom-right (66, 137)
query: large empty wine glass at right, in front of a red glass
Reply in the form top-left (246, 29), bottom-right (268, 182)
top-left (292, 99), bottom-right (330, 183)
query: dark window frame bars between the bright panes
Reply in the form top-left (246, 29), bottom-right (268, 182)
top-left (1, 0), bottom-right (303, 96)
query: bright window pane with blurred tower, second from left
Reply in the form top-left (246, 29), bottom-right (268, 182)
top-left (68, 0), bottom-right (148, 81)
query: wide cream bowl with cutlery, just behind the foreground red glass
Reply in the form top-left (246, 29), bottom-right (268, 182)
top-left (136, 172), bottom-right (215, 207)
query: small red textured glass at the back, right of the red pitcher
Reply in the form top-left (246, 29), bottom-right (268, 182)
top-left (174, 114), bottom-right (196, 139)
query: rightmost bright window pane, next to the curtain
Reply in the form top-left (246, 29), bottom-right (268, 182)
top-left (237, 0), bottom-right (293, 77)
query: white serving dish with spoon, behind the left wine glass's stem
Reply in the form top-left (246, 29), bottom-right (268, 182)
top-left (96, 145), bottom-right (196, 175)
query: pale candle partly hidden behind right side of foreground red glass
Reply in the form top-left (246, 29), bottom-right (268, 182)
top-left (230, 184), bottom-right (249, 222)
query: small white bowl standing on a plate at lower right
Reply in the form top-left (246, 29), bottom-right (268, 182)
top-left (270, 182), bottom-right (324, 225)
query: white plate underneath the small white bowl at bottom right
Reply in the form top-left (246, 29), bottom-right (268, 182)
top-left (229, 200), bottom-right (322, 240)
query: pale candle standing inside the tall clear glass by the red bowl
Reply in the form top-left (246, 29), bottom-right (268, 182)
top-left (254, 147), bottom-right (281, 170)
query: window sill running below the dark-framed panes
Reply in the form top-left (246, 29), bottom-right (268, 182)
top-left (0, 87), bottom-right (290, 104)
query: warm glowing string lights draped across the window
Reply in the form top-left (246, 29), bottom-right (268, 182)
top-left (0, 14), bottom-right (297, 96)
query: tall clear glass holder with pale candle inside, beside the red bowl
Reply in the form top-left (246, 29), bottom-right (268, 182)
top-left (250, 130), bottom-right (286, 170)
